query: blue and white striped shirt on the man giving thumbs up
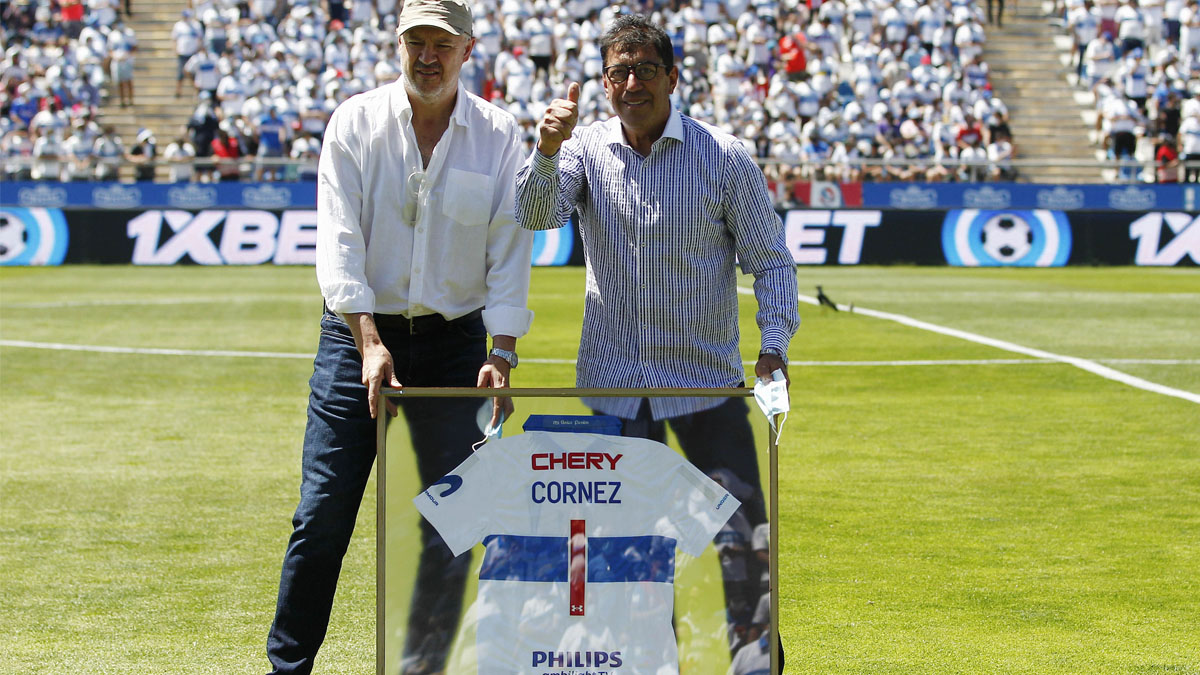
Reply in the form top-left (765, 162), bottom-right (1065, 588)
top-left (516, 110), bottom-right (799, 419)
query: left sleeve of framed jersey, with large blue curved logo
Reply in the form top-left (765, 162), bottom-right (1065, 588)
top-left (413, 454), bottom-right (492, 555)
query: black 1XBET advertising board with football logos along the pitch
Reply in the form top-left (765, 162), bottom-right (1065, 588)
top-left (0, 207), bottom-right (1200, 267)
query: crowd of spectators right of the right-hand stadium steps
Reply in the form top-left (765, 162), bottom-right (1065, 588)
top-left (1055, 0), bottom-right (1200, 183)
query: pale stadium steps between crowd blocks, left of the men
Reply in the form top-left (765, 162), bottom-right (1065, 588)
top-left (100, 0), bottom-right (196, 179)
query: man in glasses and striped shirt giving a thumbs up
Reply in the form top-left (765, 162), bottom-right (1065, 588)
top-left (516, 16), bottom-right (799, 658)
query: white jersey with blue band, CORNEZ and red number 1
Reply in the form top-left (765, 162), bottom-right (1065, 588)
top-left (414, 431), bottom-right (740, 675)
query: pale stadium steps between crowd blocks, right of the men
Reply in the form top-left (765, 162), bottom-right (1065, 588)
top-left (984, 2), bottom-right (1102, 183)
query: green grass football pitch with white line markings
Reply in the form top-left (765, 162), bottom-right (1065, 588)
top-left (0, 267), bottom-right (1200, 675)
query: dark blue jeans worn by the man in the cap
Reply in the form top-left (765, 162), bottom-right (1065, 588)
top-left (266, 312), bottom-right (487, 675)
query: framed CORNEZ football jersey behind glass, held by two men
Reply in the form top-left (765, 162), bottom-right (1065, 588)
top-left (377, 388), bottom-right (778, 675)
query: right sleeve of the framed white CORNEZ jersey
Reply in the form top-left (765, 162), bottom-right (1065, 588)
top-left (668, 458), bottom-right (742, 556)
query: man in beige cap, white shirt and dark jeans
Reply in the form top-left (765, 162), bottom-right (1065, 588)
top-left (266, 0), bottom-right (533, 675)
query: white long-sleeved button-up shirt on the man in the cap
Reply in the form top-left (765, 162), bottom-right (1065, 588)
top-left (317, 80), bottom-right (533, 338)
